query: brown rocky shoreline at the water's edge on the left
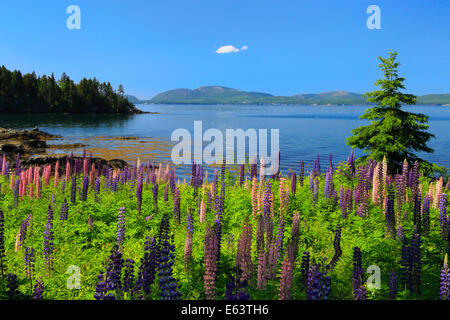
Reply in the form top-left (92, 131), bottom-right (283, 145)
top-left (0, 128), bottom-right (128, 169)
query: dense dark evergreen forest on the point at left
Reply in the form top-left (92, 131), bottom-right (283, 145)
top-left (0, 66), bottom-right (141, 113)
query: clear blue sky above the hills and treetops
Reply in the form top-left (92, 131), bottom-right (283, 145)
top-left (0, 0), bottom-right (450, 98)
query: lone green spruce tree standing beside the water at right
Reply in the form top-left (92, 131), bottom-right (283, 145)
top-left (347, 51), bottom-right (434, 174)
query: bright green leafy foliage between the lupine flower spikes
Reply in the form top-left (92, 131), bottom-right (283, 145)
top-left (0, 164), bottom-right (448, 299)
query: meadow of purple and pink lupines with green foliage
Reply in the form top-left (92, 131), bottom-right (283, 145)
top-left (0, 153), bottom-right (450, 300)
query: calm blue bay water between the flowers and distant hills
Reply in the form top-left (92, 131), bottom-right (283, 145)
top-left (0, 105), bottom-right (450, 173)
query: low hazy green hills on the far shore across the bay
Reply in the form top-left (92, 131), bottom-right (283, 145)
top-left (126, 86), bottom-right (450, 105)
